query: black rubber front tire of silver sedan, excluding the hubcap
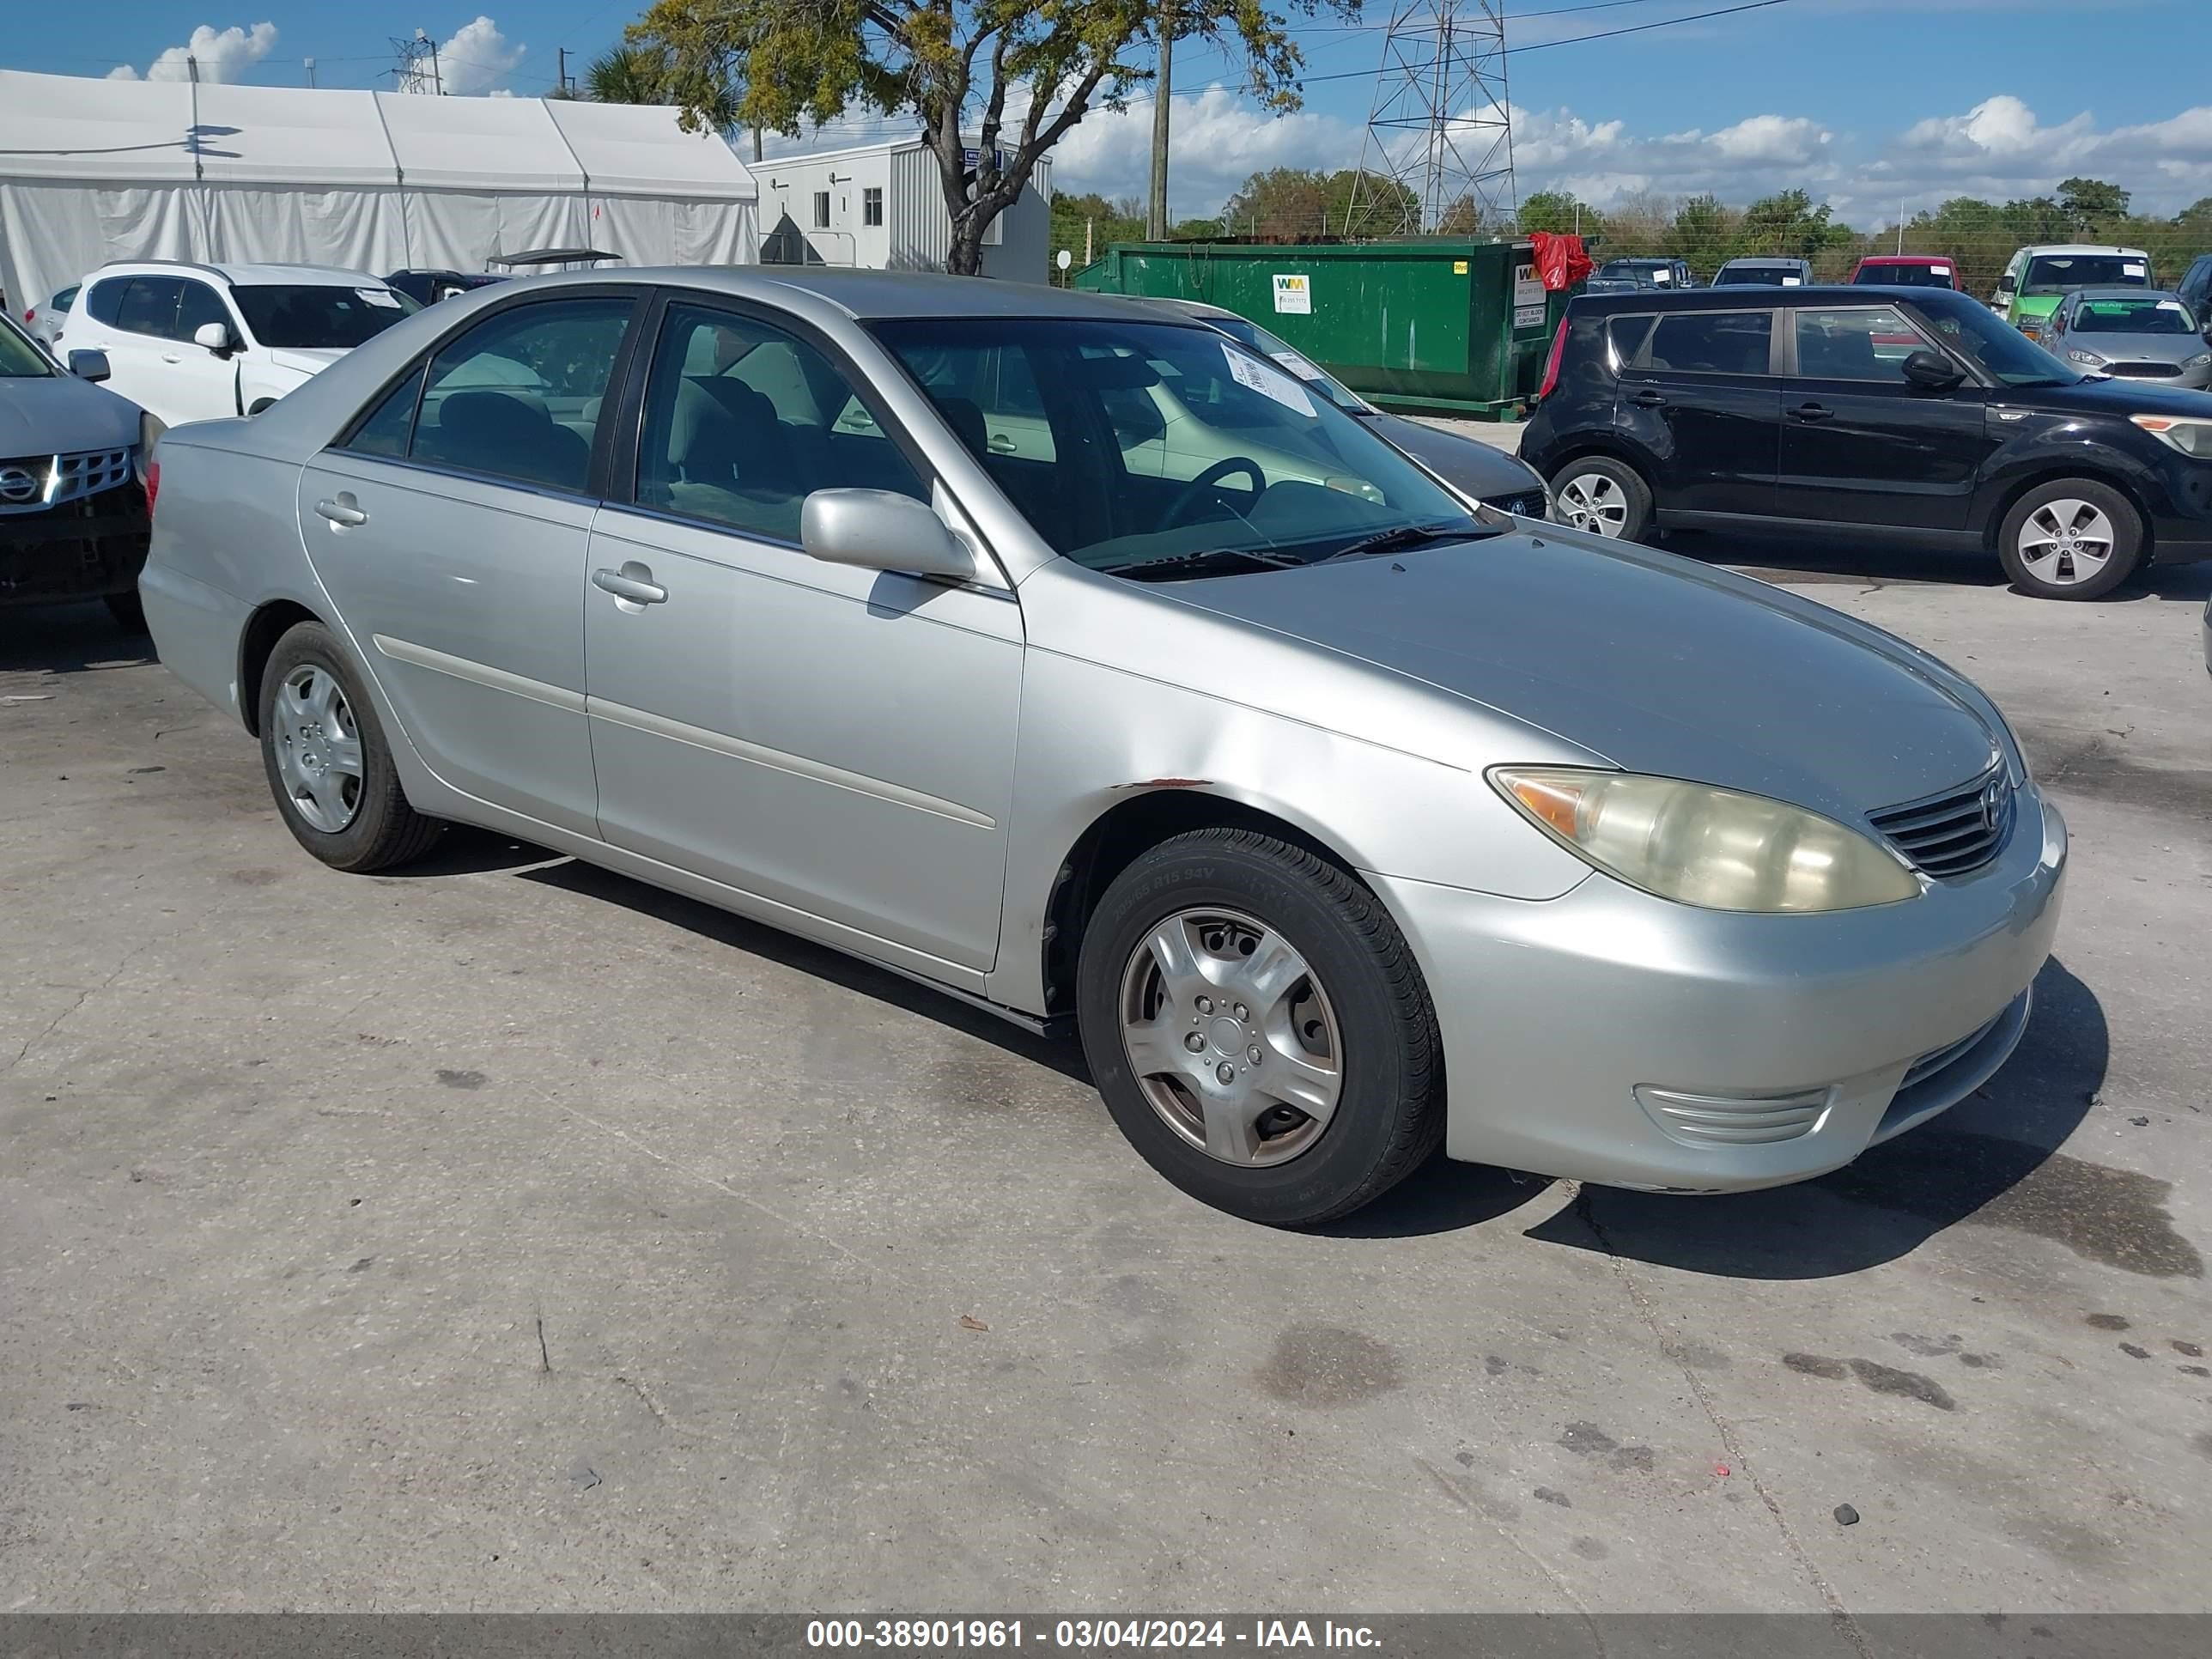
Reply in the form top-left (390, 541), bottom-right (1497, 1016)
top-left (1078, 830), bottom-right (1444, 1228)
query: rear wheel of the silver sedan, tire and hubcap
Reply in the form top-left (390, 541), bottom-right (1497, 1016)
top-left (261, 622), bottom-right (445, 872)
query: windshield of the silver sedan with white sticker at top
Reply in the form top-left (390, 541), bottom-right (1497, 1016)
top-left (876, 319), bottom-right (1493, 575)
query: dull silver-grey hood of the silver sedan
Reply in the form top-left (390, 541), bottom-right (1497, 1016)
top-left (1172, 529), bottom-right (2004, 821)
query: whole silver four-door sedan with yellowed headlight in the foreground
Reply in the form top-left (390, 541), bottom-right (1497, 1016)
top-left (142, 270), bottom-right (2066, 1225)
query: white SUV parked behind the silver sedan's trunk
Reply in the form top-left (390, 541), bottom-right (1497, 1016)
top-left (55, 258), bottom-right (422, 427)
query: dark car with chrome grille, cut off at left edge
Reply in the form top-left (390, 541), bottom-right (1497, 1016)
top-left (0, 319), bottom-right (149, 629)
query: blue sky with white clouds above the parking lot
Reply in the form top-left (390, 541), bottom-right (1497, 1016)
top-left (17, 0), bottom-right (2212, 223)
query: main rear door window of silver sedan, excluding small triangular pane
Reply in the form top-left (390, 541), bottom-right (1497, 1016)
top-left (409, 289), bottom-right (635, 493)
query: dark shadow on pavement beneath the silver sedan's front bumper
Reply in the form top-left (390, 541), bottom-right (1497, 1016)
top-left (1526, 957), bottom-right (2106, 1279)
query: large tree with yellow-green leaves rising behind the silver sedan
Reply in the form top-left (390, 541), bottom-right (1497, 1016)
top-left (629, 0), bottom-right (1358, 276)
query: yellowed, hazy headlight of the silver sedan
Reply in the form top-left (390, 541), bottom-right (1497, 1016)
top-left (1486, 765), bottom-right (1920, 911)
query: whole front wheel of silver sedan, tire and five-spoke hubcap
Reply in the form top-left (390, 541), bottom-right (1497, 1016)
top-left (1078, 830), bottom-right (1444, 1228)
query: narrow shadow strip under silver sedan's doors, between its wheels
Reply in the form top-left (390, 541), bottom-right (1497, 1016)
top-left (515, 858), bottom-right (1091, 1086)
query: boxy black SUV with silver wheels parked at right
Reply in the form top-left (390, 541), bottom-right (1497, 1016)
top-left (1522, 288), bottom-right (2212, 599)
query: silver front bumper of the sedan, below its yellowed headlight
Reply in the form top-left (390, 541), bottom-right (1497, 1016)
top-left (1370, 787), bottom-right (2066, 1192)
